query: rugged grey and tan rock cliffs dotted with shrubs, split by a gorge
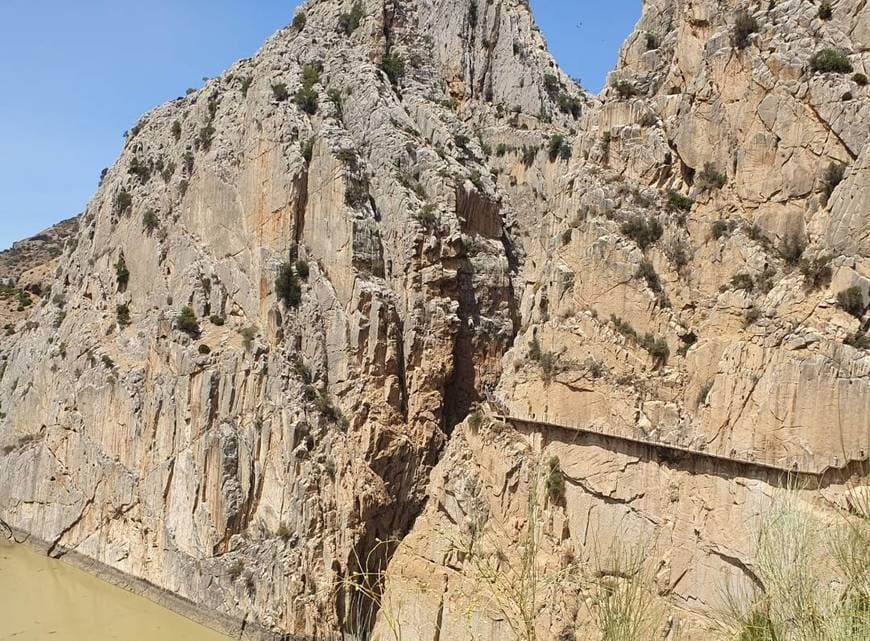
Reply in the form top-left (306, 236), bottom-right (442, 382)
top-left (0, 0), bottom-right (870, 641)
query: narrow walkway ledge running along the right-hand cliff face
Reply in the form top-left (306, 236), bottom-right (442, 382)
top-left (492, 414), bottom-right (868, 477)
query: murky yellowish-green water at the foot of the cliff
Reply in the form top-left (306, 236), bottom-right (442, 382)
top-left (0, 536), bottom-right (229, 641)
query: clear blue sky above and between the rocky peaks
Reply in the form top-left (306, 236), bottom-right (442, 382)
top-left (0, 0), bottom-right (640, 248)
